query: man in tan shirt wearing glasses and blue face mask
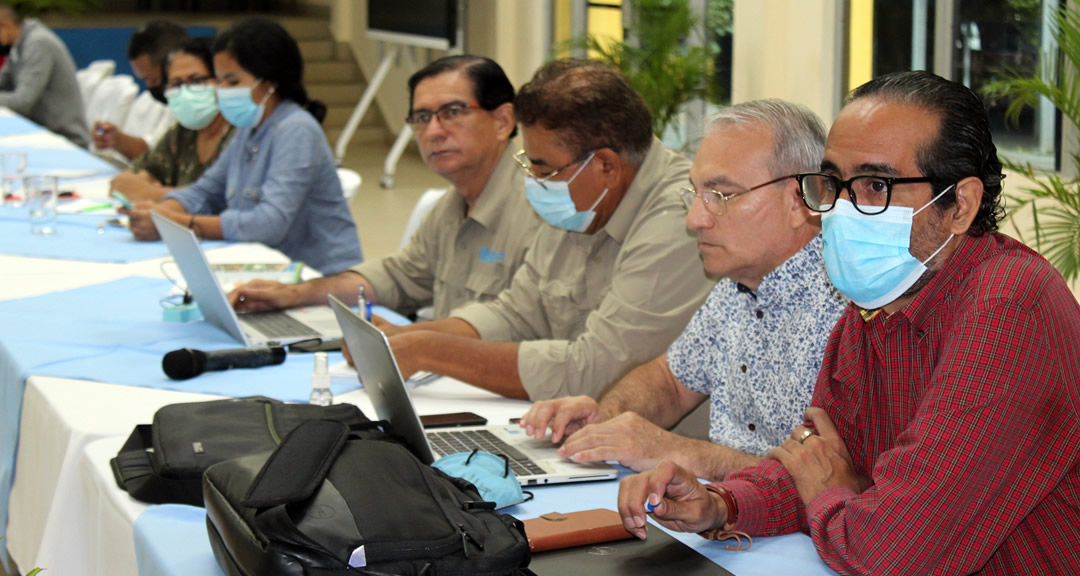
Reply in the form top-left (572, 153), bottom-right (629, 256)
top-left (387, 61), bottom-right (713, 400)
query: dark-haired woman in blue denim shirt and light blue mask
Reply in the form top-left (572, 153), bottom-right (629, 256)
top-left (124, 17), bottom-right (363, 274)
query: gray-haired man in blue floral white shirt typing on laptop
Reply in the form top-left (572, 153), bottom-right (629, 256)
top-left (522, 99), bottom-right (848, 479)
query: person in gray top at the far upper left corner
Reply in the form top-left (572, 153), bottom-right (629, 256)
top-left (0, 2), bottom-right (90, 148)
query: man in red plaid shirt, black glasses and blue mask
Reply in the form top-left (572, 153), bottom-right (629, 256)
top-left (619, 71), bottom-right (1080, 575)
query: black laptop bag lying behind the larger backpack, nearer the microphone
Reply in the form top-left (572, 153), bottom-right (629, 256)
top-left (111, 397), bottom-right (368, 506)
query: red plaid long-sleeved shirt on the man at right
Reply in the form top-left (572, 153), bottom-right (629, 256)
top-left (724, 235), bottom-right (1080, 575)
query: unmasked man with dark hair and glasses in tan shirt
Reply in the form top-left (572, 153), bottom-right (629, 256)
top-left (230, 55), bottom-right (541, 319)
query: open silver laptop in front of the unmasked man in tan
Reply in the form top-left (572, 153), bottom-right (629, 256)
top-left (150, 212), bottom-right (341, 346)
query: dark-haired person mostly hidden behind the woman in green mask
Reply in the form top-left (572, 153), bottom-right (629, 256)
top-left (92, 19), bottom-right (188, 160)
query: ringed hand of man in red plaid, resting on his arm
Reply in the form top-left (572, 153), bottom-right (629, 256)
top-left (769, 407), bottom-right (869, 505)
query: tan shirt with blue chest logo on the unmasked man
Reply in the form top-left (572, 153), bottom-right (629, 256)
top-left (352, 146), bottom-right (541, 313)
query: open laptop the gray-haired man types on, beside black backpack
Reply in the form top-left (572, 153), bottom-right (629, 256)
top-left (329, 295), bottom-right (619, 486)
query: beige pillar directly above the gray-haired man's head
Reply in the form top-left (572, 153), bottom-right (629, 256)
top-left (731, 0), bottom-right (842, 125)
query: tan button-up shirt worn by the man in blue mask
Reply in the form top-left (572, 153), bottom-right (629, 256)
top-left (453, 139), bottom-right (714, 400)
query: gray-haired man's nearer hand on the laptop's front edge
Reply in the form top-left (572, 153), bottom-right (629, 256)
top-left (558, 412), bottom-right (689, 472)
